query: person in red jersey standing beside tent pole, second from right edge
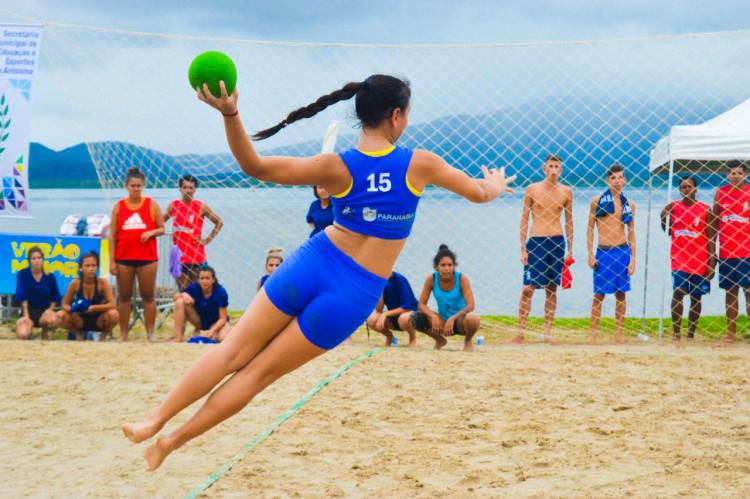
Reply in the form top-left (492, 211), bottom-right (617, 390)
top-left (661, 176), bottom-right (716, 341)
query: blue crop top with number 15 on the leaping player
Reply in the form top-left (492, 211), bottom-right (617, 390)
top-left (331, 146), bottom-right (422, 239)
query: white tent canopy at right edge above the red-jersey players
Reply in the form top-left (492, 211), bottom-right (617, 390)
top-left (648, 99), bottom-right (750, 173)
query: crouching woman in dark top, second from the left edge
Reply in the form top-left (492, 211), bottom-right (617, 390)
top-left (60, 251), bottom-right (120, 340)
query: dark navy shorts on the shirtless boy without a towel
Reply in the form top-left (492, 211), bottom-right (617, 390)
top-left (523, 236), bottom-right (565, 288)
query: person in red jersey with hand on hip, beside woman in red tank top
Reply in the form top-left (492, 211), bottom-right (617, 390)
top-left (164, 175), bottom-right (224, 290)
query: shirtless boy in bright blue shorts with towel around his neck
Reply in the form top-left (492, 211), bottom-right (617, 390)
top-left (586, 163), bottom-right (635, 342)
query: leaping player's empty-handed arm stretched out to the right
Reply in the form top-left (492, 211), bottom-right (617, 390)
top-left (409, 150), bottom-right (516, 203)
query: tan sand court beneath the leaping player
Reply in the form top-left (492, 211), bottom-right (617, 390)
top-left (0, 335), bottom-right (750, 497)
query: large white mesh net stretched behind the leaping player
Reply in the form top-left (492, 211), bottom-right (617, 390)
top-left (30, 24), bottom-right (750, 338)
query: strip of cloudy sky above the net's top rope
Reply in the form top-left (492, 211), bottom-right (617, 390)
top-left (8, 0), bottom-right (750, 43)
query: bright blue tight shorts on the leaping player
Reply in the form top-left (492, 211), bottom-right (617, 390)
top-left (263, 232), bottom-right (388, 349)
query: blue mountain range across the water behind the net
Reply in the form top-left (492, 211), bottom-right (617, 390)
top-left (29, 96), bottom-right (734, 188)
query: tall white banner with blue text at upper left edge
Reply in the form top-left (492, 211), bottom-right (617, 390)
top-left (0, 24), bottom-right (42, 216)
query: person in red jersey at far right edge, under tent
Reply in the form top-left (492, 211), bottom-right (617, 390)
top-left (714, 161), bottom-right (750, 342)
